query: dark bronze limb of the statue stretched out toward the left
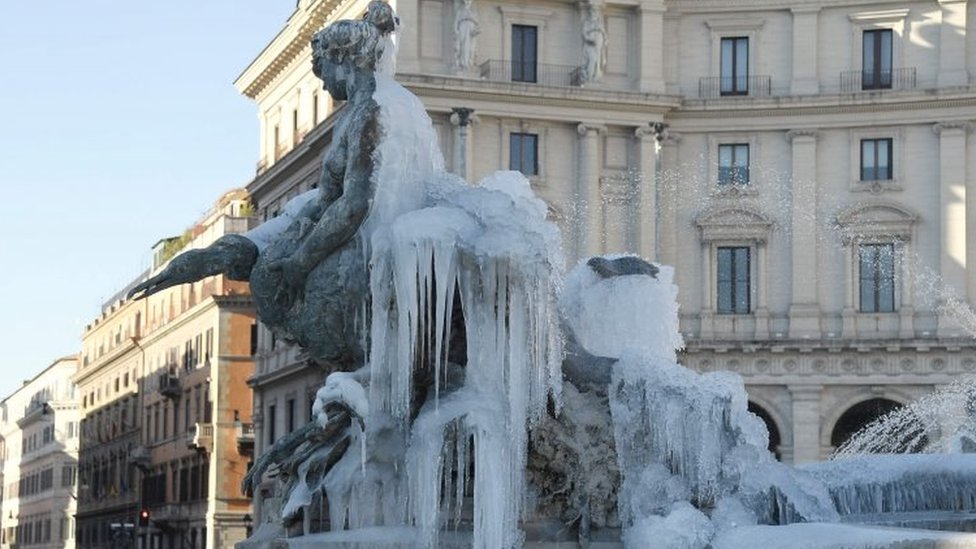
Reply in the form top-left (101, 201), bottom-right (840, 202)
top-left (128, 234), bottom-right (258, 299)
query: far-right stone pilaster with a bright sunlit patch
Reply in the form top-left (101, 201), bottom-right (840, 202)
top-left (933, 121), bottom-right (969, 336)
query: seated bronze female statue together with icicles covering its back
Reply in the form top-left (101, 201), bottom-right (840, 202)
top-left (132, 1), bottom-right (562, 548)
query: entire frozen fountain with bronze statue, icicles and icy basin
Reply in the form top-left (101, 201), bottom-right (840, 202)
top-left (133, 2), bottom-right (976, 549)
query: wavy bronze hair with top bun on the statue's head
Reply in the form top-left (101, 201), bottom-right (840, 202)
top-left (312, 0), bottom-right (399, 70)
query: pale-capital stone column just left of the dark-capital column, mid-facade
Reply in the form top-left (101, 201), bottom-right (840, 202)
top-left (575, 122), bottom-right (603, 259)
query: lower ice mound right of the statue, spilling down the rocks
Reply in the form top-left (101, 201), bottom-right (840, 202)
top-left (561, 265), bottom-right (837, 547)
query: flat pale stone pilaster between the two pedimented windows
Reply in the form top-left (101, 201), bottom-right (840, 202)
top-left (786, 130), bottom-right (820, 339)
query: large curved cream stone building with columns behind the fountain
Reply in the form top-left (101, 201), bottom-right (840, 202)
top-left (236, 0), bottom-right (976, 524)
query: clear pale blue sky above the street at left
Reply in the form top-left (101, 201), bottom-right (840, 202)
top-left (0, 0), bottom-right (295, 398)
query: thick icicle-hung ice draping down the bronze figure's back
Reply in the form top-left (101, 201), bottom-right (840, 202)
top-left (278, 76), bottom-right (562, 548)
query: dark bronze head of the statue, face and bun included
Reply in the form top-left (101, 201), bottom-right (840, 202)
top-left (312, 0), bottom-right (398, 99)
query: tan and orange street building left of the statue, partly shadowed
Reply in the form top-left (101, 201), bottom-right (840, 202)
top-left (75, 189), bottom-right (255, 549)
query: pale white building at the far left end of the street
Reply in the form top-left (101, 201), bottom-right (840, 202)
top-left (0, 356), bottom-right (81, 549)
